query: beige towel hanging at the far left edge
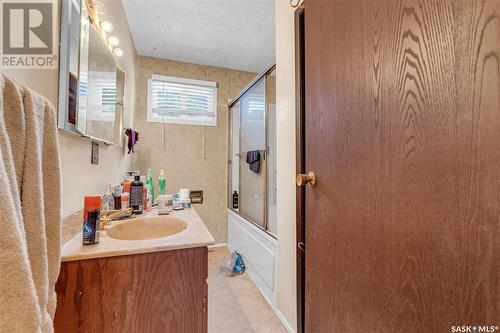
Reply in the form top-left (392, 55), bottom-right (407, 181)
top-left (0, 75), bottom-right (61, 332)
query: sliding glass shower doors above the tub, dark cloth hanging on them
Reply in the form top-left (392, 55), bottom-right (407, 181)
top-left (229, 66), bottom-right (276, 236)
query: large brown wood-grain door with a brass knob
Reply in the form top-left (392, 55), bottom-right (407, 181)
top-left (305, 0), bottom-right (500, 333)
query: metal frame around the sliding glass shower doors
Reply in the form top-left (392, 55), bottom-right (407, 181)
top-left (227, 63), bottom-right (277, 239)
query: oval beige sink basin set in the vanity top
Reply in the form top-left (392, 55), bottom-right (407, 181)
top-left (106, 216), bottom-right (187, 240)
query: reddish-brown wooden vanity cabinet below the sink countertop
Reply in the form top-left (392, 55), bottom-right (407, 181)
top-left (54, 247), bottom-right (208, 333)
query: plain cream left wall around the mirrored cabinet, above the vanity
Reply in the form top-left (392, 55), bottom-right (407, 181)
top-left (2, 0), bottom-right (136, 216)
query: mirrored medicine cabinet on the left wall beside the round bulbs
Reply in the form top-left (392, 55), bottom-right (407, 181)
top-left (58, 0), bottom-right (125, 145)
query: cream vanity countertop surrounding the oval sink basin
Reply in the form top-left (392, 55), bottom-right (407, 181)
top-left (61, 208), bottom-right (215, 262)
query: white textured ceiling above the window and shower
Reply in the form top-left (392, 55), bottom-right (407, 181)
top-left (122, 0), bottom-right (275, 72)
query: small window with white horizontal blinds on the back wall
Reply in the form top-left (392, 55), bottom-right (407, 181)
top-left (147, 75), bottom-right (217, 126)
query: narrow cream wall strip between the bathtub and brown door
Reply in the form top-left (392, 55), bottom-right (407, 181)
top-left (275, 0), bottom-right (297, 330)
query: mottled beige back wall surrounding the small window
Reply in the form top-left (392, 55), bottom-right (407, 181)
top-left (134, 56), bottom-right (255, 243)
